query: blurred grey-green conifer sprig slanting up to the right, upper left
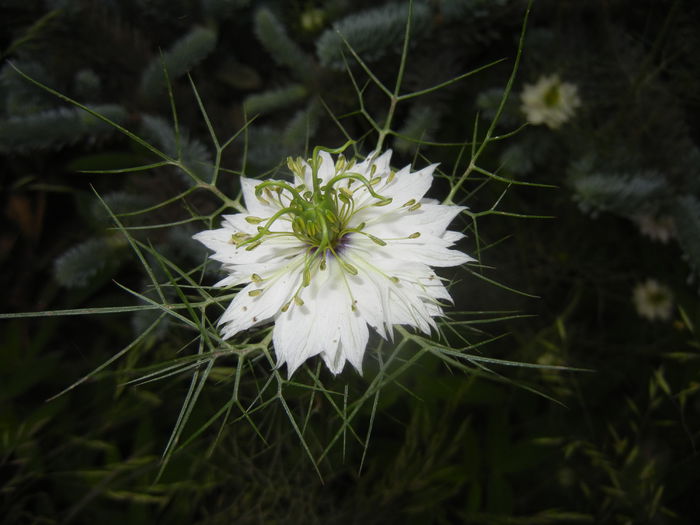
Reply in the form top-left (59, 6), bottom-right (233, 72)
top-left (141, 27), bottom-right (217, 99)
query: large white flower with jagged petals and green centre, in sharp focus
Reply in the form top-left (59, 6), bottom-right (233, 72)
top-left (194, 148), bottom-right (473, 376)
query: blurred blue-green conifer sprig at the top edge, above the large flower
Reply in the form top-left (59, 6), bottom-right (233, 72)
top-left (316, 1), bottom-right (430, 70)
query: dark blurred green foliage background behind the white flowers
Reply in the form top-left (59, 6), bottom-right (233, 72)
top-left (0, 0), bottom-right (700, 524)
